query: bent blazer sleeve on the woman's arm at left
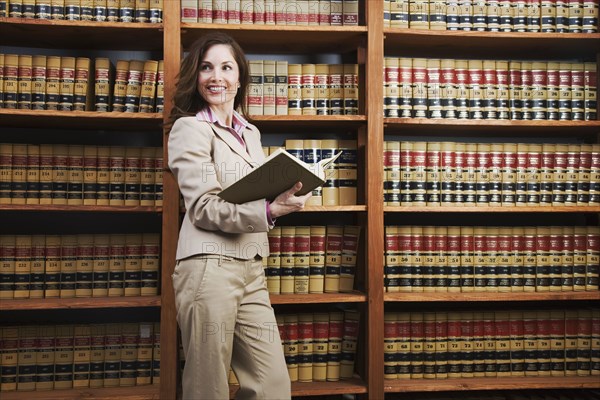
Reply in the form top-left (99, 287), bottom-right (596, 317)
top-left (168, 117), bottom-right (269, 234)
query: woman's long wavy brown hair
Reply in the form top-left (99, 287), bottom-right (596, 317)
top-left (165, 32), bottom-right (250, 128)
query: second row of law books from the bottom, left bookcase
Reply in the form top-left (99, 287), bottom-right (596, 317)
top-left (0, 233), bottom-right (160, 300)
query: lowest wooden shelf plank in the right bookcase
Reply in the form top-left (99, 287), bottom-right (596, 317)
top-left (384, 376), bottom-right (600, 393)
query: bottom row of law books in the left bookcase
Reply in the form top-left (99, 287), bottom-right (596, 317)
top-left (0, 322), bottom-right (160, 397)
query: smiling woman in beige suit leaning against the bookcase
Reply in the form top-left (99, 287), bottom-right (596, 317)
top-left (168, 32), bottom-right (310, 399)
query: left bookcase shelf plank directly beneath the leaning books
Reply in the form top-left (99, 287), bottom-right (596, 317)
top-left (0, 109), bottom-right (162, 133)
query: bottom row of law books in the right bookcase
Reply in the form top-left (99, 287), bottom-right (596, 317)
top-left (384, 308), bottom-right (600, 379)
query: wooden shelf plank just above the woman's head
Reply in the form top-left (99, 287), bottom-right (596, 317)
top-left (181, 23), bottom-right (367, 54)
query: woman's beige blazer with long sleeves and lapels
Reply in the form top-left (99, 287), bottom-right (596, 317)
top-left (168, 117), bottom-right (270, 260)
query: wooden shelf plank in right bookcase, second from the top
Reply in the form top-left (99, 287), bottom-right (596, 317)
top-left (384, 118), bottom-right (600, 137)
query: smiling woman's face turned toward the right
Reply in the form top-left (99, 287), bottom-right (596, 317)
top-left (198, 44), bottom-right (240, 109)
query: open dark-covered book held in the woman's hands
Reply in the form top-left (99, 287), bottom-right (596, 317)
top-left (219, 148), bottom-right (342, 204)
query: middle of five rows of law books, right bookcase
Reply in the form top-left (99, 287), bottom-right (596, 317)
top-left (384, 141), bottom-right (600, 207)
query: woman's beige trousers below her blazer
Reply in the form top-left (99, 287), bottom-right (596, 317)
top-left (173, 255), bottom-right (291, 400)
